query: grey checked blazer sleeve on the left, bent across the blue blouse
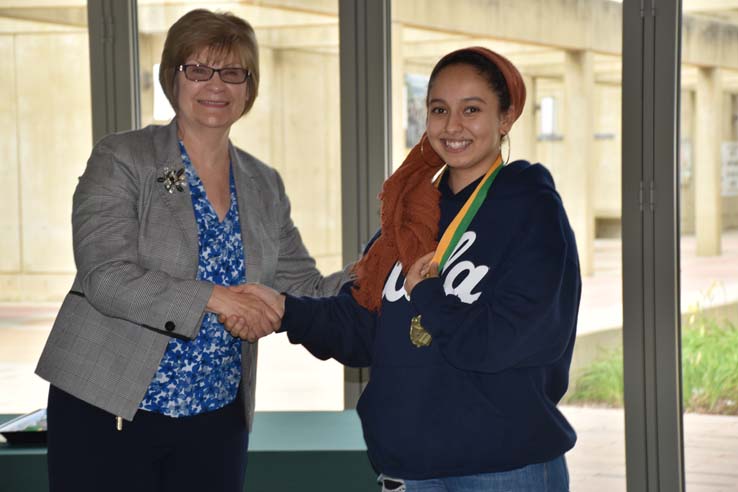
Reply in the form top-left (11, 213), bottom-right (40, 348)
top-left (72, 137), bottom-right (213, 338)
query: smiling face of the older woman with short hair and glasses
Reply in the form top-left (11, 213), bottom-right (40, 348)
top-left (175, 50), bottom-right (249, 135)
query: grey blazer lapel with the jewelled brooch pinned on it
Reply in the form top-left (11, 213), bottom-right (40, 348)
top-left (154, 119), bottom-right (199, 266)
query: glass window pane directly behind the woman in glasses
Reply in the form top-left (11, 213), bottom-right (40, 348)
top-left (138, 0), bottom-right (343, 410)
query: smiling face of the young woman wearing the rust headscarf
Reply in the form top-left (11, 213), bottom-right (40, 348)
top-left (426, 64), bottom-right (512, 191)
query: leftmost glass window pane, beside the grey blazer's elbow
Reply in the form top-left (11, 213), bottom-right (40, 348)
top-left (0, 0), bottom-right (92, 414)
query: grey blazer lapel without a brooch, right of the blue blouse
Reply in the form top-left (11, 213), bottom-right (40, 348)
top-left (230, 145), bottom-right (267, 282)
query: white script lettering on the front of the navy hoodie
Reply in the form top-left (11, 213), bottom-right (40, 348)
top-left (382, 231), bottom-right (489, 304)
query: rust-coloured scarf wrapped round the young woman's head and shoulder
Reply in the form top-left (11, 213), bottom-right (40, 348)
top-left (352, 46), bottom-right (525, 311)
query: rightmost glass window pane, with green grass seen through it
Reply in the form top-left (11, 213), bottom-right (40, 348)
top-left (679, 0), bottom-right (738, 491)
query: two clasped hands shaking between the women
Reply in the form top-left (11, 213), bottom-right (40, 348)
top-left (208, 284), bottom-right (284, 343)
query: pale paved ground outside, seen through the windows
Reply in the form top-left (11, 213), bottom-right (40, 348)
top-left (0, 231), bottom-right (738, 492)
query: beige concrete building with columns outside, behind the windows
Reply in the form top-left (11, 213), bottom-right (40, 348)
top-left (0, 0), bottom-right (738, 300)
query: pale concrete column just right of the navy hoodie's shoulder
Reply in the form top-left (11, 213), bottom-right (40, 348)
top-left (556, 51), bottom-right (596, 275)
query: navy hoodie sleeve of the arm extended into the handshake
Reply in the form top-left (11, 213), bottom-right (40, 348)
top-left (280, 283), bottom-right (376, 367)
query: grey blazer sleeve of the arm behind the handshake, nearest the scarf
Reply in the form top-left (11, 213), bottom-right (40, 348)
top-left (274, 171), bottom-right (352, 297)
